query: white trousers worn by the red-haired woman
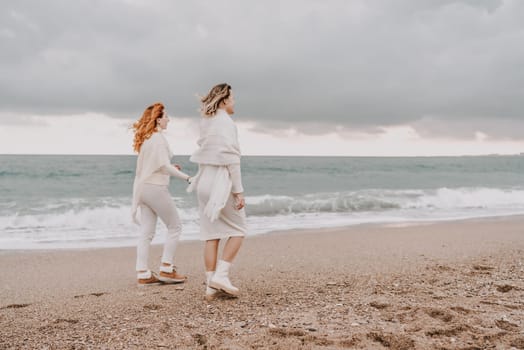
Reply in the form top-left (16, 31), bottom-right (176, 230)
top-left (136, 184), bottom-right (182, 271)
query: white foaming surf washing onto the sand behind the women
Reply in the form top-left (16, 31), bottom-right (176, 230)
top-left (0, 188), bottom-right (524, 249)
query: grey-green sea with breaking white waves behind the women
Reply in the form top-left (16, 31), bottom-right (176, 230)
top-left (0, 155), bottom-right (524, 250)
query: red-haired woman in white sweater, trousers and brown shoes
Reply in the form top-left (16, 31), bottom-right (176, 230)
top-left (132, 103), bottom-right (190, 285)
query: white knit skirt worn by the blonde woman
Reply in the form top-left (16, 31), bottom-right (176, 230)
top-left (196, 164), bottom-right (247, 241)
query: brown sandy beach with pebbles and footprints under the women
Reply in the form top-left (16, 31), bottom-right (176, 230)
top-left (0, 217), bottom-right (524, 349)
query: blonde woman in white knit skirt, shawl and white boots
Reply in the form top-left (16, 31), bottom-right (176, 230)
top-left (188, 84), bottom-right (246, 300)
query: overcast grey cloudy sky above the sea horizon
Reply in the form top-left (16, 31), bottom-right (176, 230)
top-left (0, 0), bottom-right (524, 156)
